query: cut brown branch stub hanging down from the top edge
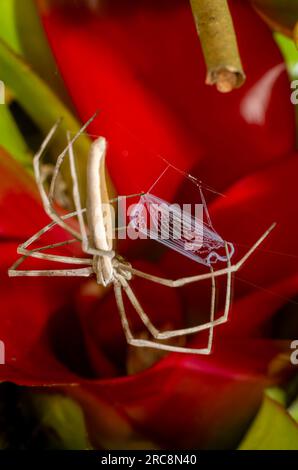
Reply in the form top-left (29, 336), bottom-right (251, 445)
top-left (190, 0), bottom-right (245, 93)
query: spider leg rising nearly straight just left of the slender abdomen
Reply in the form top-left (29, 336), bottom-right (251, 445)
top-left (67, 133), bottom-right (115, 258)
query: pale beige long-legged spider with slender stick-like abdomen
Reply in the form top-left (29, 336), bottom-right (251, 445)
top-left (8, 116), bottom-right (276, 355)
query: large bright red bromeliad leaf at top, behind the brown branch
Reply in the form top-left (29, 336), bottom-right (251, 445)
top-left (37, 0), bottom-right (294, 196)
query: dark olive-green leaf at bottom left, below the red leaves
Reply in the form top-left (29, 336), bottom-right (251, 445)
top-left (31, 393), bottom-right (91, 450)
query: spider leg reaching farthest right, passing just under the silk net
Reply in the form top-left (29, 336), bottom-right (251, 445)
top-left (128, 223), bottom-right (276, 287)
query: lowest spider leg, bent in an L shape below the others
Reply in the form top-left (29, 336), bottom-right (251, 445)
top-left (114, 281), bottom-right (213, 355)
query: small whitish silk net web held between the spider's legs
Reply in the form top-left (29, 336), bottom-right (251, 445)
top-left (130, 164), bottom-right (235, 267)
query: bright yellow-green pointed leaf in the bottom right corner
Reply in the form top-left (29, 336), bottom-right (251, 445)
top-left (239, 395), bottom-right (298, 450)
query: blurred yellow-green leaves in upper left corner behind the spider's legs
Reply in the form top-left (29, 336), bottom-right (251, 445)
top-left (0, 0), bottom-right (90, 194)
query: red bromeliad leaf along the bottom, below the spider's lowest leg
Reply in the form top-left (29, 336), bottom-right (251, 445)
top-left (66, 340), bottom-right (294, 449)
